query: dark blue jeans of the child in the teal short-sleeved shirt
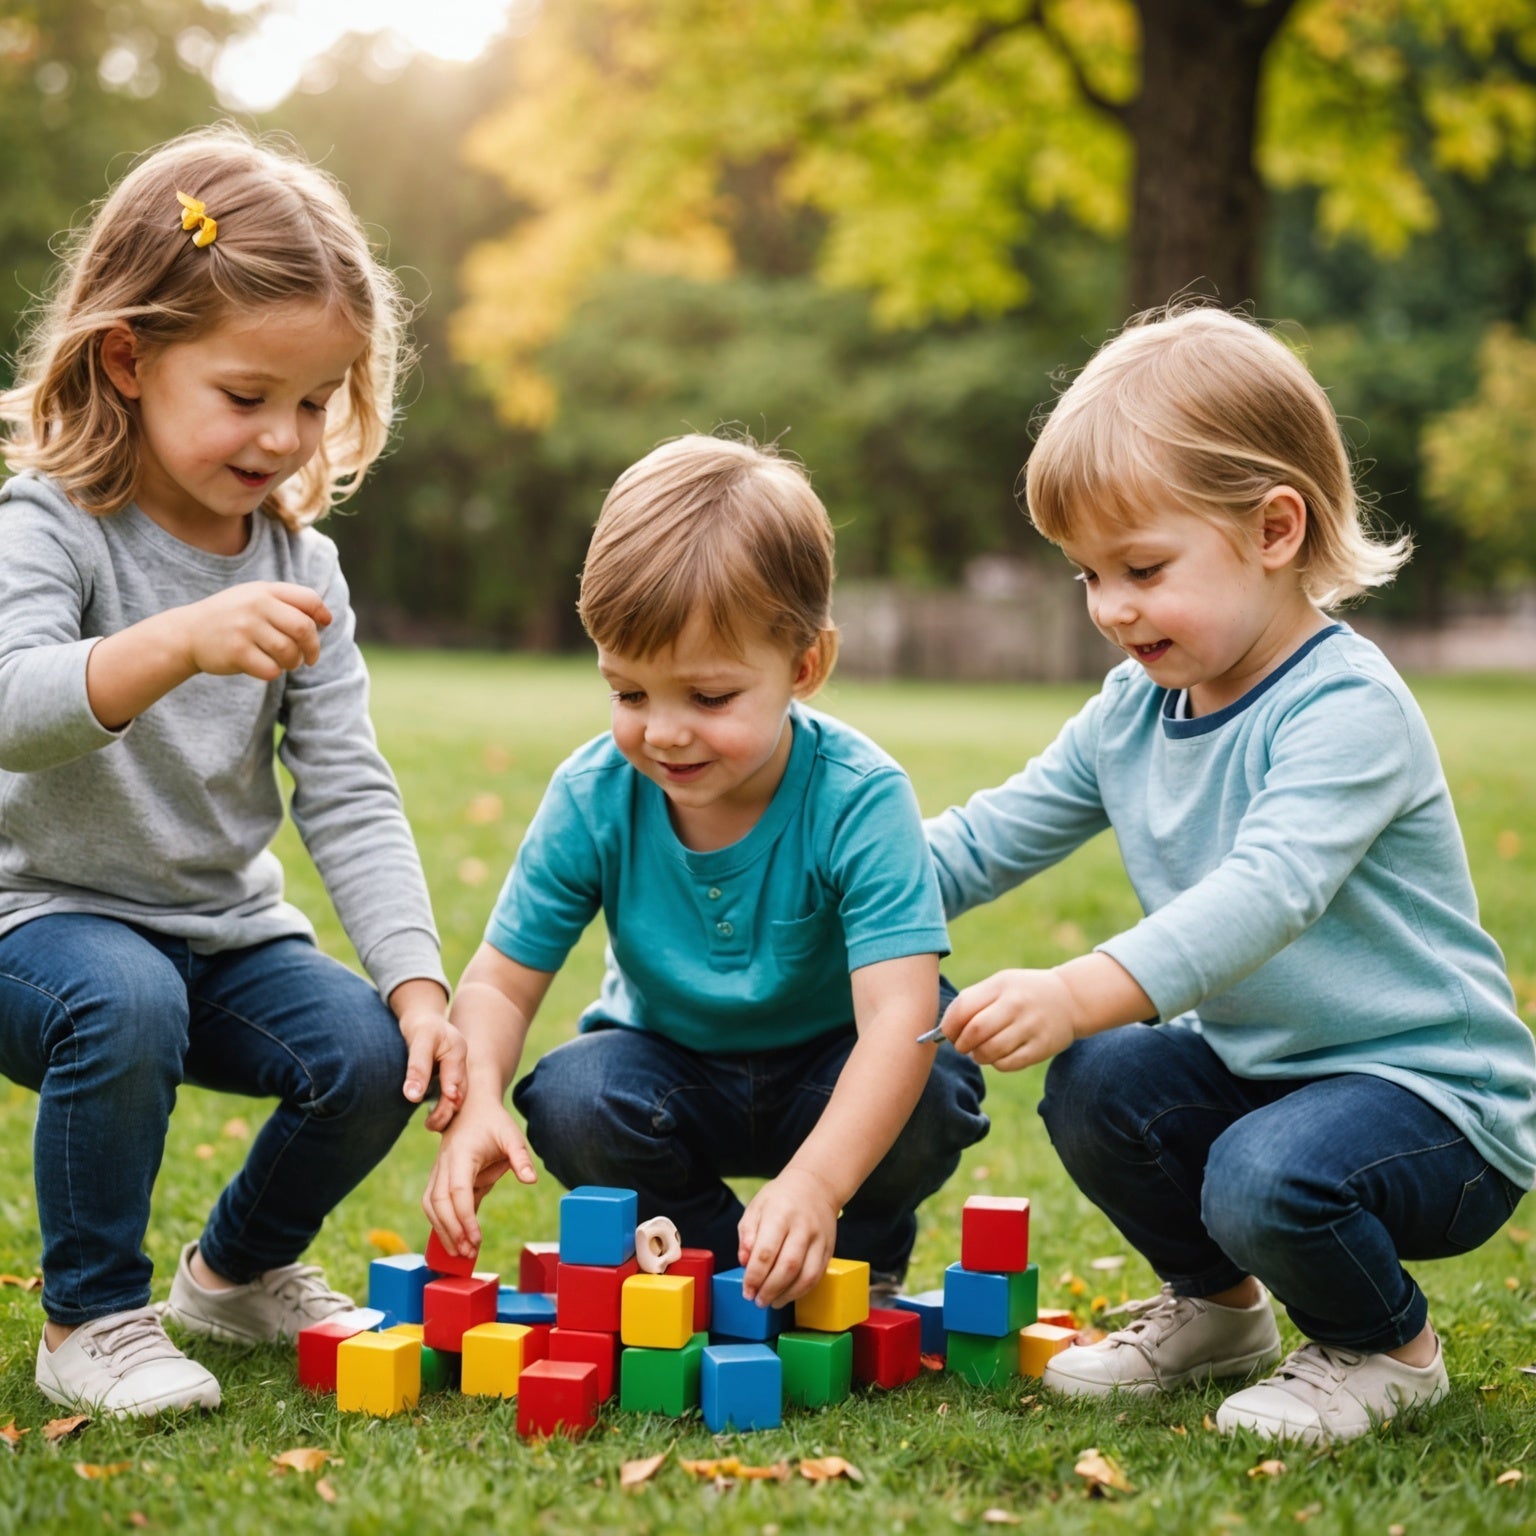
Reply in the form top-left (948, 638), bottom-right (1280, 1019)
top-left (513, 1007), bottom-right (989, 1279)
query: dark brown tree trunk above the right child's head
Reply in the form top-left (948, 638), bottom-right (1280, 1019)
top-left (1124, 0), bottom-right (1295, 310)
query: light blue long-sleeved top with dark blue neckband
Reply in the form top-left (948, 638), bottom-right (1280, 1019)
top-left (926, 625), bottom-right (1536, 1187)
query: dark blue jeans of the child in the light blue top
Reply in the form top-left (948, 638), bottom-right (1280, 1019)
top-left (1040, 1025), bottom-right (1521, 1352)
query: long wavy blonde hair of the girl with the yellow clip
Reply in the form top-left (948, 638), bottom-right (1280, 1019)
top-left (0, 124), bottom-right (409, 528)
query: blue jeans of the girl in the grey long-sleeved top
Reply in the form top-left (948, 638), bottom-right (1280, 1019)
top-left (0, 915), bottom-right (413, 1326)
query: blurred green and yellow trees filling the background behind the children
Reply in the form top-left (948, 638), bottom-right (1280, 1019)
top-left (0, 0), bottom-right (1536, 647)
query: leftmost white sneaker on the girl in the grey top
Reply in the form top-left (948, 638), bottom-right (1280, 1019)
top-left (37, 1307), bottom-right (220, 1416)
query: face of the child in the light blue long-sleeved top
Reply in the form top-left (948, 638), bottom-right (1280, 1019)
top-left (1061, 503), bottom-right (1319, 714)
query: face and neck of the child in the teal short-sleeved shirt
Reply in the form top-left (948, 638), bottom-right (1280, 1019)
top-left (598, 616), bottom-right (816, 846)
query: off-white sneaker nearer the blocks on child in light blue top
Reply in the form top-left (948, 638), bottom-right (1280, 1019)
top-left (1041, 1286), bottom-right (1279, 1396)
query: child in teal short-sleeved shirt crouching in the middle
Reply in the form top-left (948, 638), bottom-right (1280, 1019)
top-left (422, 436), bottom-right (988, 1306)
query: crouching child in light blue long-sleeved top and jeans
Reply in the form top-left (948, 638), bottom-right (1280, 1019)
top-left (928, 309), bottom-right (1536, 1442)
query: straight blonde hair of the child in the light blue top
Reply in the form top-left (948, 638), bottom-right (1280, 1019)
top-left (1023, 304), bottom-right (1412, 608)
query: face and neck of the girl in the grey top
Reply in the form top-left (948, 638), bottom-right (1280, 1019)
top-left (103, 304), bottom-right (362, 554)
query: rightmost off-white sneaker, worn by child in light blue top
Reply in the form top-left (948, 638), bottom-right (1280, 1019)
top-left (1217, 1338), bottom-right (1450, 1445)
